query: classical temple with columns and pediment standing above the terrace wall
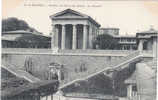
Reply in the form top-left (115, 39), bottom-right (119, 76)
top-left (50, 9), bottom-right (100, 50)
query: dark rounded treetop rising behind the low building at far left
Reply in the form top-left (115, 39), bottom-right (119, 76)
top-left (2, 17), bottom-right (30, 32)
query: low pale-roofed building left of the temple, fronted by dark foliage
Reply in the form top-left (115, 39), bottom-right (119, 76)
top-left (2, 30), bottom-right (51, 48)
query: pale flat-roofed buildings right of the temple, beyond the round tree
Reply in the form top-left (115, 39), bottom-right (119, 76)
top-left (99, 28), bottom-right (158, 51)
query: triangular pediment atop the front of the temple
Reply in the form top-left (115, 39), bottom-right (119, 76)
top-left (51, 9), bottom-right (87, 18)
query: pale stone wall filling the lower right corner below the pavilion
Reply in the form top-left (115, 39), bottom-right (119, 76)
top-left (136, 59), bottom-right (157, 100)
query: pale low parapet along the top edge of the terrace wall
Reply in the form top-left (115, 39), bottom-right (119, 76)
top-left (2, 48), bottom-right (135, 56)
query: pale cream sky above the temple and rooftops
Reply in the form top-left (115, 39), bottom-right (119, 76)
top-left (2, 0), bottom-right (158, 35)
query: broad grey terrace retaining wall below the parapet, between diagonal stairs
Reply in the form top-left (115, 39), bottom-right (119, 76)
top-left (2, 53), bottom-right (128, 83)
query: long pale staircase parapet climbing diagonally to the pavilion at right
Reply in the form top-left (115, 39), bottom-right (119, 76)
top-left (59, 51), bottom-right (143, 89)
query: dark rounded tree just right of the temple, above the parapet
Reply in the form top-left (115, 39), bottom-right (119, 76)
top-left (93, 34), bottom-right (118, 49)
